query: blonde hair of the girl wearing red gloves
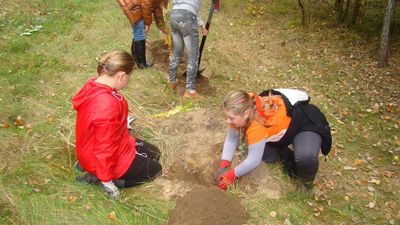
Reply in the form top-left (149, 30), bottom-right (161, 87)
top-left (222, 90), bottom-right (254, 115)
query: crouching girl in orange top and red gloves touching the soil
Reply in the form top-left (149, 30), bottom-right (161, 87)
top-left (214, 89), bottom-right (332, 190)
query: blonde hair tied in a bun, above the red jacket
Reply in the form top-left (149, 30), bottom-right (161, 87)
top-left (97, 49), bottom-right (135, 76)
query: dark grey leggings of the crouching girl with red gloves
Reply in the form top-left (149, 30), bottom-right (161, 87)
top-left (263, 131), bottom-right (322, 180)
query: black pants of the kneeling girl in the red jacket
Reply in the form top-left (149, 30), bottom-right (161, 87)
top-left (119, 139), bottom-right (162, 188)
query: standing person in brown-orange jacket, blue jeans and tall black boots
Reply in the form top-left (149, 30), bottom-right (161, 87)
top-left (118, 0), bottom-right (168, 69)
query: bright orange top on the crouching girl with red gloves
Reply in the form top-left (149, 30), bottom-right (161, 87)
top-left (246, 95), bottom-right (291, 144)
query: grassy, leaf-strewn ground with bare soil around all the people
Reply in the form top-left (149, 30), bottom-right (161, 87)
top-left (0, 0), bottom-right (400, 225)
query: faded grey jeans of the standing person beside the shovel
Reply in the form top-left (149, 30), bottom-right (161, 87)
top-left (168, 9), bottom-right (199, 90)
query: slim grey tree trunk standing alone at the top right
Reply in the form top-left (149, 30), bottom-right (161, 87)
top-left (378, 0), bottom-right (396, 67)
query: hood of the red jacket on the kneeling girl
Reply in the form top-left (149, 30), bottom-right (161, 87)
top-left (72, 77), bottom-right (115, 110)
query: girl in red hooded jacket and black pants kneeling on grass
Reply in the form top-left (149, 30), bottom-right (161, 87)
top-left (72, 50), bottom-right (162, 197)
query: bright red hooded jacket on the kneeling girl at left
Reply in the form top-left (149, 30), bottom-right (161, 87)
top-left (72, 77), bottom-right (136, 181)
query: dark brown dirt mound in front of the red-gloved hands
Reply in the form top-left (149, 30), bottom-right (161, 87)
top-left (168, 186), bottom-right (248, 225)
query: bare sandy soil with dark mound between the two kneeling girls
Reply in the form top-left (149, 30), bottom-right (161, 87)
top-left (154, 109), bottom-right (287, 224)
